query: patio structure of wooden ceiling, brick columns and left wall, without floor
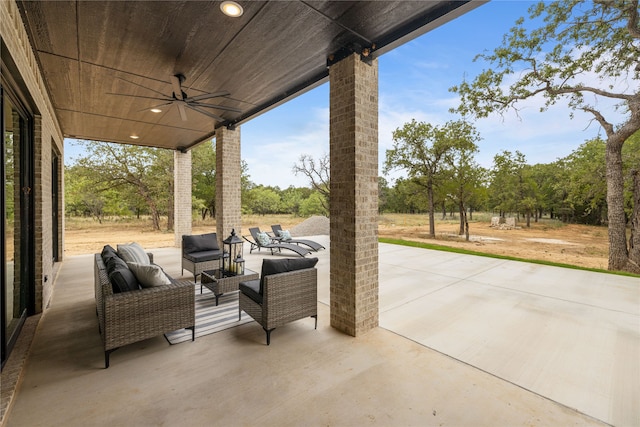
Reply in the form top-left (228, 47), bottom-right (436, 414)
top-left (0, 0), bottom-right (485, 384)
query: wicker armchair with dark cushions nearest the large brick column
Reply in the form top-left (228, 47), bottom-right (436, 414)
top-left (238, 258), bottom-right (318, 345)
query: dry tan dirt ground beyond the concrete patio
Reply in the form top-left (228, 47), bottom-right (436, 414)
top-left (65, 215), bottom-right (608, 269)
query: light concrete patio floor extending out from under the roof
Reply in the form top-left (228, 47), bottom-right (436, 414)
top-left (5, 236), bottom-right (640, 426)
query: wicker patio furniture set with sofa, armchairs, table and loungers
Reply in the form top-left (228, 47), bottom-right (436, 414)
top-left (94, 233), bottom-right (322, 368)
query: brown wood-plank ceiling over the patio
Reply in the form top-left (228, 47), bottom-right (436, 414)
top-left (18, 0), bottom-right (484, 150)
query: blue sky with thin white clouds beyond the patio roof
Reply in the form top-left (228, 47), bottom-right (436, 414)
top-left (66, 0), bottom-right (624, 189)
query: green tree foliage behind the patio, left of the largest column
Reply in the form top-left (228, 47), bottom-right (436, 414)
top-left (65, 141), bottom-right (340, 224)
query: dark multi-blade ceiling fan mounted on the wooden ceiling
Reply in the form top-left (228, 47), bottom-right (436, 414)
top-left (109, 74), bottom-right (242, 122)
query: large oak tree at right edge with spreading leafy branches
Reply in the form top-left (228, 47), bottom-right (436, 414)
top-left (451, 0), bottom-right (640, 272)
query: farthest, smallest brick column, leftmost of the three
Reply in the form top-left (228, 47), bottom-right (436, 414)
top-left (173, 150), bottom-right (193, 248)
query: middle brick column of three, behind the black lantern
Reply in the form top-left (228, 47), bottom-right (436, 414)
top-left (216, 127), bottom-right (242, 247)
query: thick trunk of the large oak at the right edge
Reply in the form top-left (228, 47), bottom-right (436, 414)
top-left (605, 136), bottom-right (629, 270)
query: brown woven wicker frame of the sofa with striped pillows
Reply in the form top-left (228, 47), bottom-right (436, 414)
top-left (94, 247), bottom-right (195, 368)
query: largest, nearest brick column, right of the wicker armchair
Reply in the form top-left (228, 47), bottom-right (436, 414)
top-left (329, 54), bottom-right (378, 336)
